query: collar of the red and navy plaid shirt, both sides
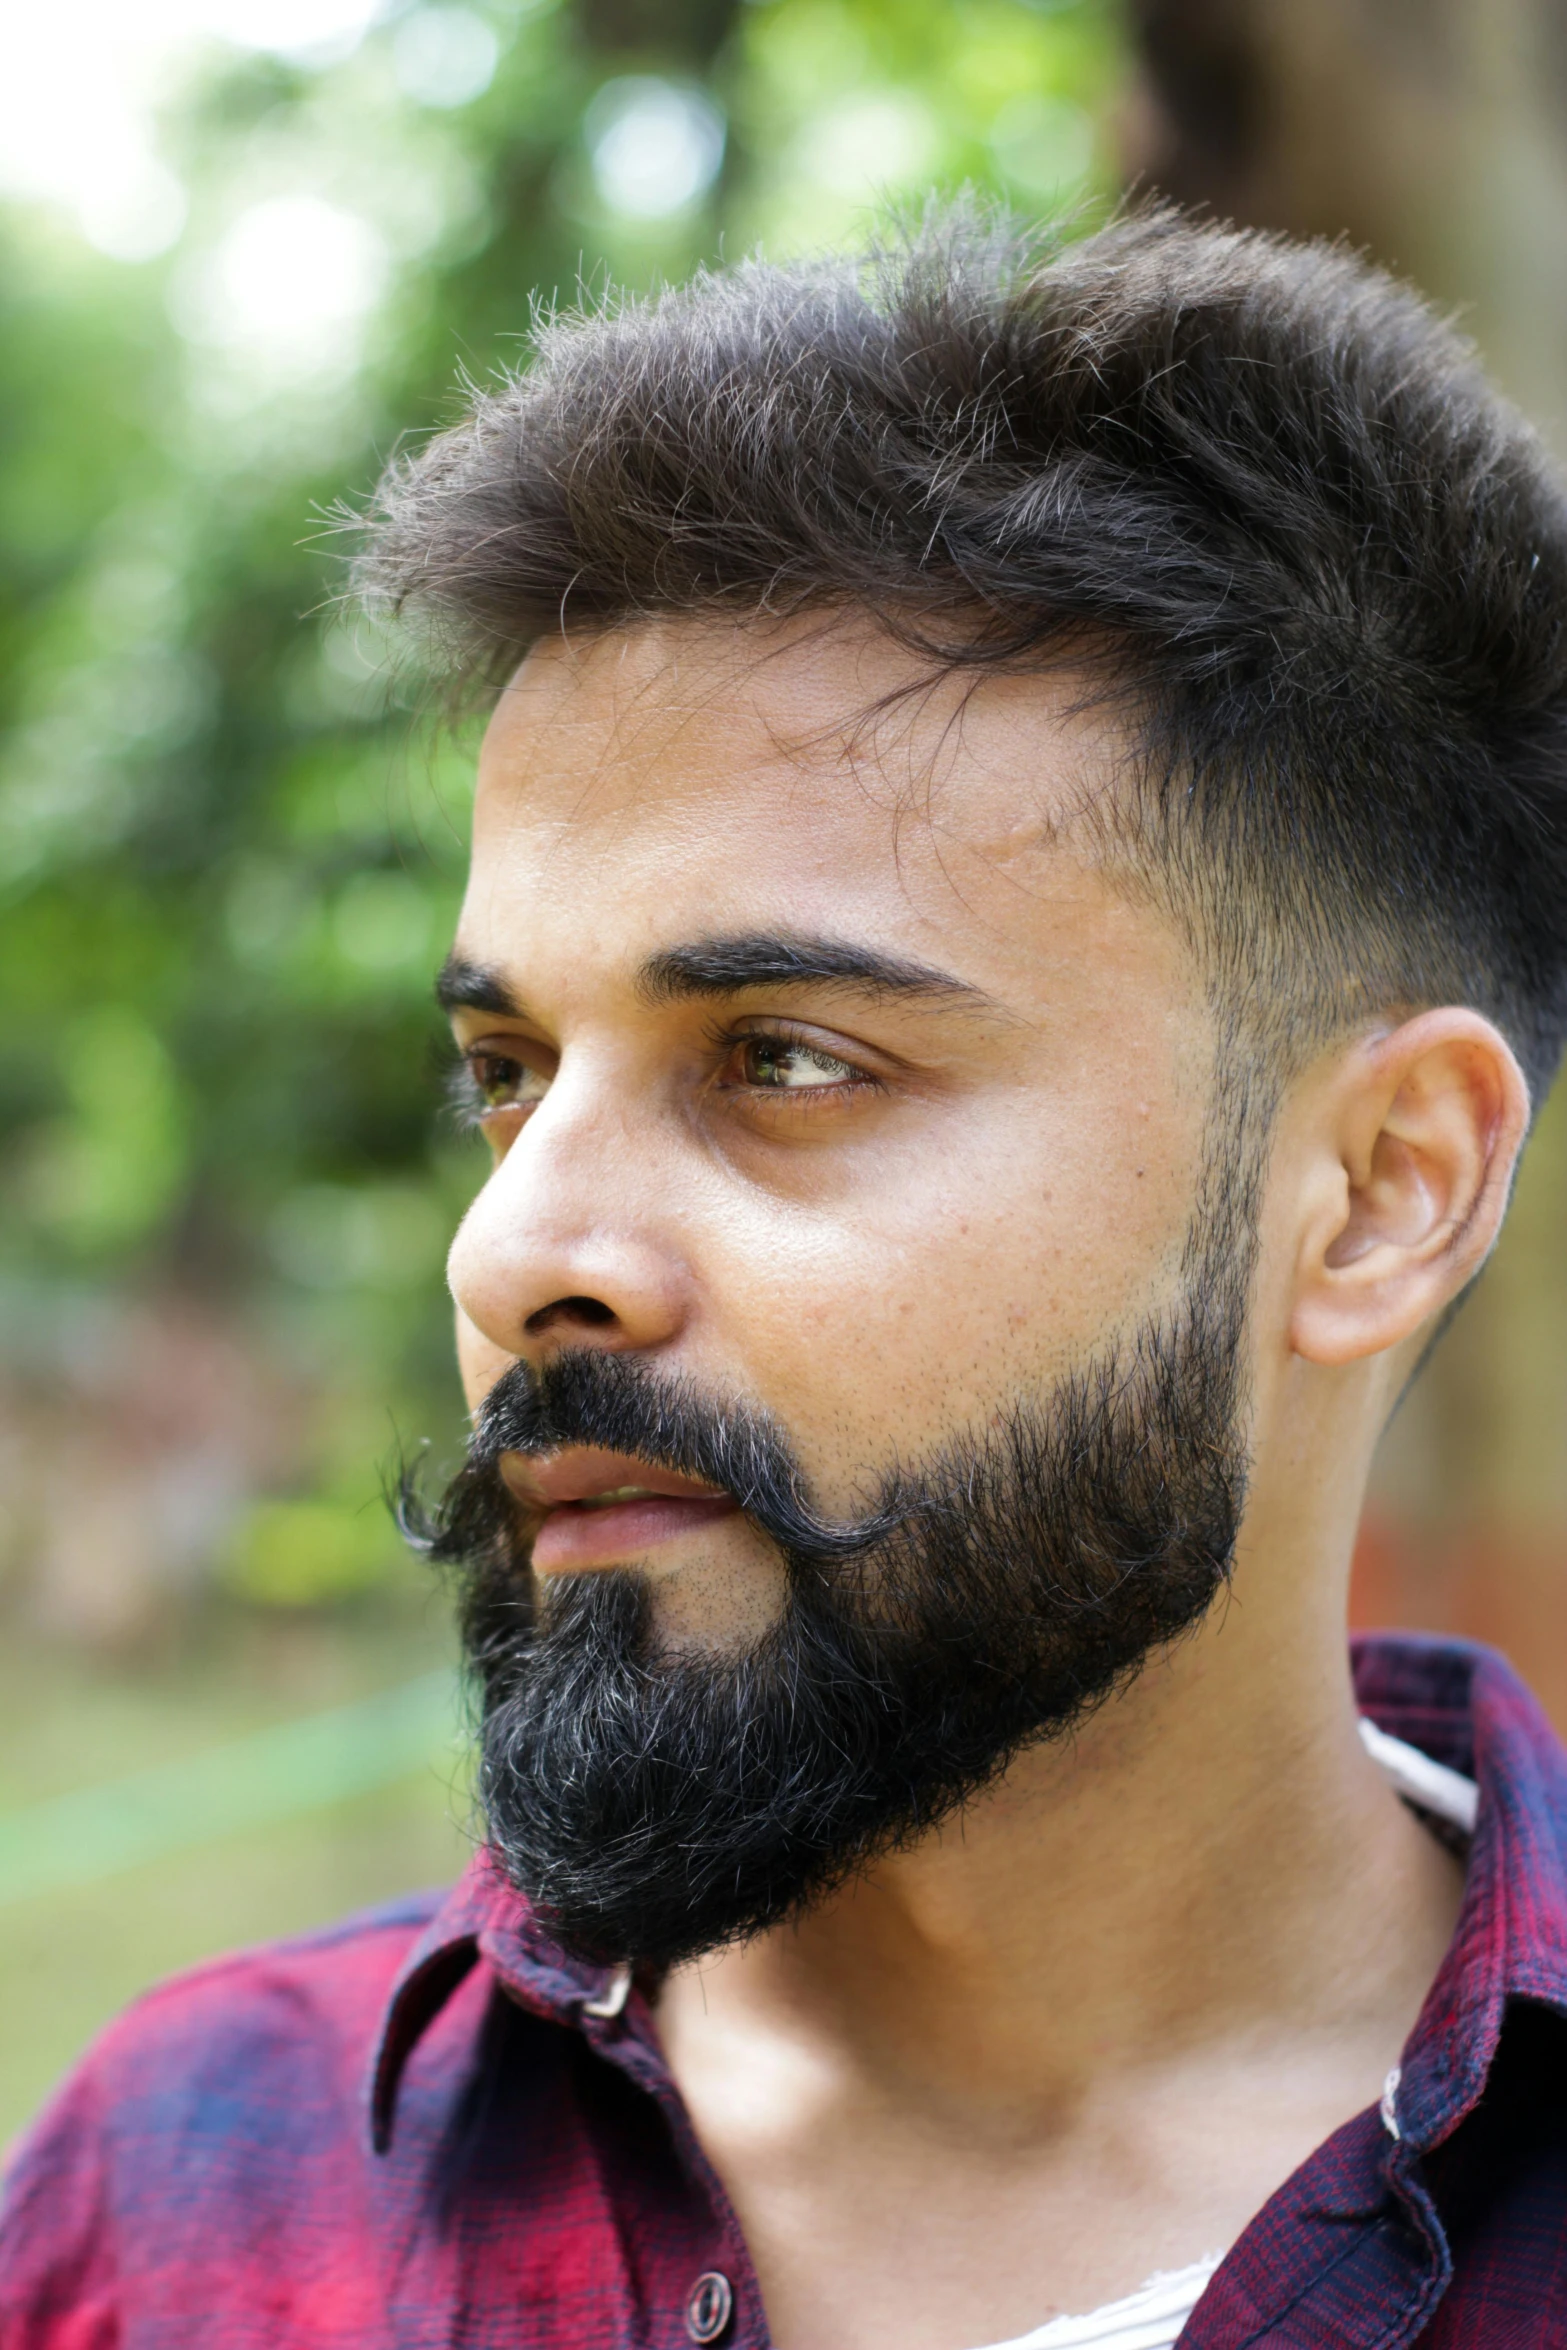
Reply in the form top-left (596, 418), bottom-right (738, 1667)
top-left (369, 1633), bottom-right (1567, 2155)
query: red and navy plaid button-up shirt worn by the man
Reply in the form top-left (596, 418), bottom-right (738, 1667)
top-left (0, 1638), bottom-right (1567, 2350)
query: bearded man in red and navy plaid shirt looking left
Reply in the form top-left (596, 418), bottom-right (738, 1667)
top-left (0, 214), bottom-right (1567, 2350)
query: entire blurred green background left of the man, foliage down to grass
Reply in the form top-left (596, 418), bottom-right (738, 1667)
top-left (0, 0), bottom-right (1125, 2139)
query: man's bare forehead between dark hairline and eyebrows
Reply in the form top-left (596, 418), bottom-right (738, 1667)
top-left (460, 618), bottom-right (1169, 1005)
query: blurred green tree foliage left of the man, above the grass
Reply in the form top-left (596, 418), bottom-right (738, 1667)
top-left (0, 0), bottom-right (1121, 1605)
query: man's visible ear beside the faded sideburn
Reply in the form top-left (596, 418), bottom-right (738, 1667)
top-left (1290, 1006), bottom-right (1529, 1363)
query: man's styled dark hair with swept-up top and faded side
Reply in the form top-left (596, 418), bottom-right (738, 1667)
top-left (359, 204), bottom-right (1567, 1102)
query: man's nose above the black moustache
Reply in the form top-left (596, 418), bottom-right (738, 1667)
top-left (446, 1076), bottom-right (691, 1363)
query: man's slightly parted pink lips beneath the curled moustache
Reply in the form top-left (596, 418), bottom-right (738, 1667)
top-left (498, 1445), bottom-right (738, 1575)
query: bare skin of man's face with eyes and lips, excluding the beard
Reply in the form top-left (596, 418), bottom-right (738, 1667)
top-left (451, 623), bottom-right (1212, 1647)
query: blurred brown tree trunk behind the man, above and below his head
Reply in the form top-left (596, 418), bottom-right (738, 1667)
top-left (1123, 0), bottom-right (1567, 1723)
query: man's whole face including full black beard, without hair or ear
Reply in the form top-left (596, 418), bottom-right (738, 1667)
top-left (425, 630), bottom-right (1252, 1962)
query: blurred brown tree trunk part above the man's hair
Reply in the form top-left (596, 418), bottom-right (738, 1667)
top-left (1125, 0), bottom-right (1567, 454)
